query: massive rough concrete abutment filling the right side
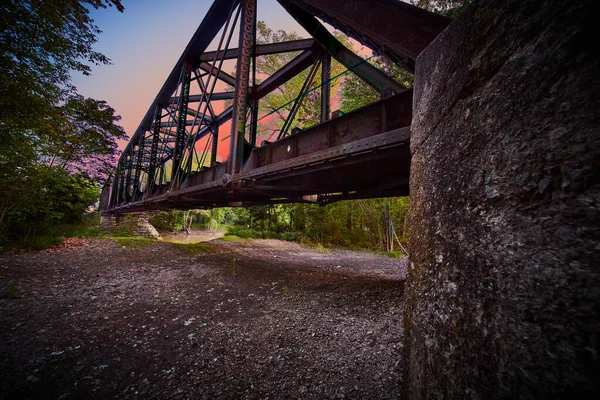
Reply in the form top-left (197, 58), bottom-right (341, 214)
top-left (404, 0), bottom-right (600, 399)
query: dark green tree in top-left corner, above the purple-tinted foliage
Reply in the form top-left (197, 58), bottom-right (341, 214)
top-left (0, 0), bottom-right (123, 135)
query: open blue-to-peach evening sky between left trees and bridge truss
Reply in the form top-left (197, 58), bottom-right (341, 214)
top-left (73, 0), bottom-right (370, 153)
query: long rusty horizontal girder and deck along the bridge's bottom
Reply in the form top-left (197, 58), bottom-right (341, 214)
top-left (106, 90), bottom-right (412, 213)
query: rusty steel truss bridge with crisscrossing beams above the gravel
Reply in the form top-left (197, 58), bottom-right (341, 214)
top-left (100, 0), bottom-right (449, 213)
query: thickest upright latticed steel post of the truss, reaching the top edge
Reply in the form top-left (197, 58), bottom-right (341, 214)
top-left (227, 0), bottom-right (256, 175)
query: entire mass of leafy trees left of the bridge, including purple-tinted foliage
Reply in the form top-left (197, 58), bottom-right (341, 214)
top-left (0, 0), bottom-right (126, 245)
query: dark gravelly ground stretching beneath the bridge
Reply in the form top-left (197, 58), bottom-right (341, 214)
top-left (0, 239), bottom-right (406, 399)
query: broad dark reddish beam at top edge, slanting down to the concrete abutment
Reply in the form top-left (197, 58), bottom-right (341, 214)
top-left (279, 0), bottom-right (451, 72)
